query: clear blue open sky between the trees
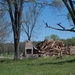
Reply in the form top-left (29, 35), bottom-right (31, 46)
top-left (4, 1), bottom-right (75, 42)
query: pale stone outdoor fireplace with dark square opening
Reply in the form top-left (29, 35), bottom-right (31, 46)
top-left (25, 40), bottom-right (33, 58)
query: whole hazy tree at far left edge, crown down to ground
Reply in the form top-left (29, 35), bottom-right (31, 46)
top-left (0, 18), bottom-right (10, 54)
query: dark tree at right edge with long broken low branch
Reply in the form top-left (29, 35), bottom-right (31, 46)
top-left (44, 0), bottom-right (75, 32)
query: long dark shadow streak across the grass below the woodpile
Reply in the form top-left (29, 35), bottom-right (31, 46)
top-left (27, 59), bottom-right (75, 66)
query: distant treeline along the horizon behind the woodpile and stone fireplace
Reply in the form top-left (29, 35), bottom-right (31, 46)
top-left (0, 35), bottom-right (75, 55)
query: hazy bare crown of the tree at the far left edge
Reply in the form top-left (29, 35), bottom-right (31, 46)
top-left (0, 19), bottom-right (10, 44)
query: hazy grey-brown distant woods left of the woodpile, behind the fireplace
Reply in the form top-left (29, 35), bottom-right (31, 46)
top-left (0, 41), bottom-right (38, 55)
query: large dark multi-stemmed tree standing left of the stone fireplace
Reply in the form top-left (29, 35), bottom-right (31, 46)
top-left (0, 0), bottom-right (24, 59)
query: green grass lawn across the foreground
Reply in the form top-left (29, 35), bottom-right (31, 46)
top-left (0, 56), bottom-right (75, 75)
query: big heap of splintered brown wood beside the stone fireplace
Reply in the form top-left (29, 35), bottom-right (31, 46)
top-left (36, 40), bottom-right (64, 57)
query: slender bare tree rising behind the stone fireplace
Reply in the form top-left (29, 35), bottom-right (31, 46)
top-left (22, 3), bottom-right (42, 40)
